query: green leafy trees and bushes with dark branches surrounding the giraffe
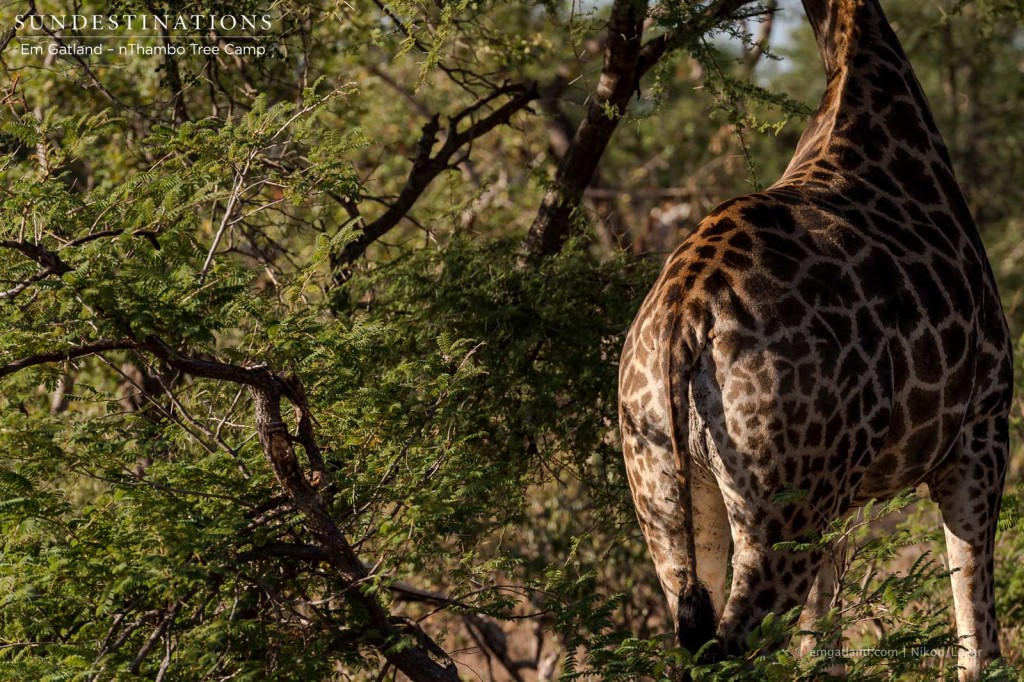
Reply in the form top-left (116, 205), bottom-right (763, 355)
top-left (0, 0), bottom-right (1024, 680)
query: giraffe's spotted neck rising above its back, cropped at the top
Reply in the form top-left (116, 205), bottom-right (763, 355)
top-left (780, 0), bottom-right (952, 181)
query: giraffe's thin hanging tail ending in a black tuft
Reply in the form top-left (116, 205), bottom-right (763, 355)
top-left (665, 318), bottom-right (718, 655)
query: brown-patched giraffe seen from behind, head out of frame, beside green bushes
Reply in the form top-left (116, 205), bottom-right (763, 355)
top-left (618, 0), bottom-right (1013, 679)
